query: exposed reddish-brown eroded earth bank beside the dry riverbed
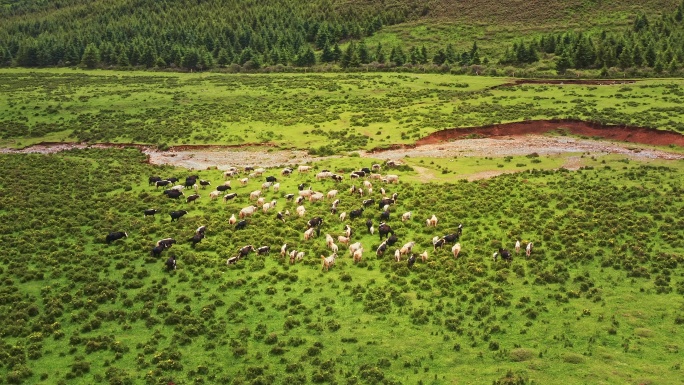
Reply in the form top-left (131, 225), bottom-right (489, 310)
top-left (416, 120), bottom-right (684, 147)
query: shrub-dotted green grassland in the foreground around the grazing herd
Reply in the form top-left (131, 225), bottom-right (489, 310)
top-left (0, 149), bottom-right (684, 384)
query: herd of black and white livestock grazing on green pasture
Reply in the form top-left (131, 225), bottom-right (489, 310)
top-left (105, 164), bottom-right (532, 271)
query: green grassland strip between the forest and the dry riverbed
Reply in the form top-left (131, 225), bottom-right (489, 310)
top-left (0, 70), bottom-right (684, 151)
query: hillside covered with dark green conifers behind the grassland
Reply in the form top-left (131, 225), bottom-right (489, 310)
top-left (0, 0), bottom-right (684, 76)
